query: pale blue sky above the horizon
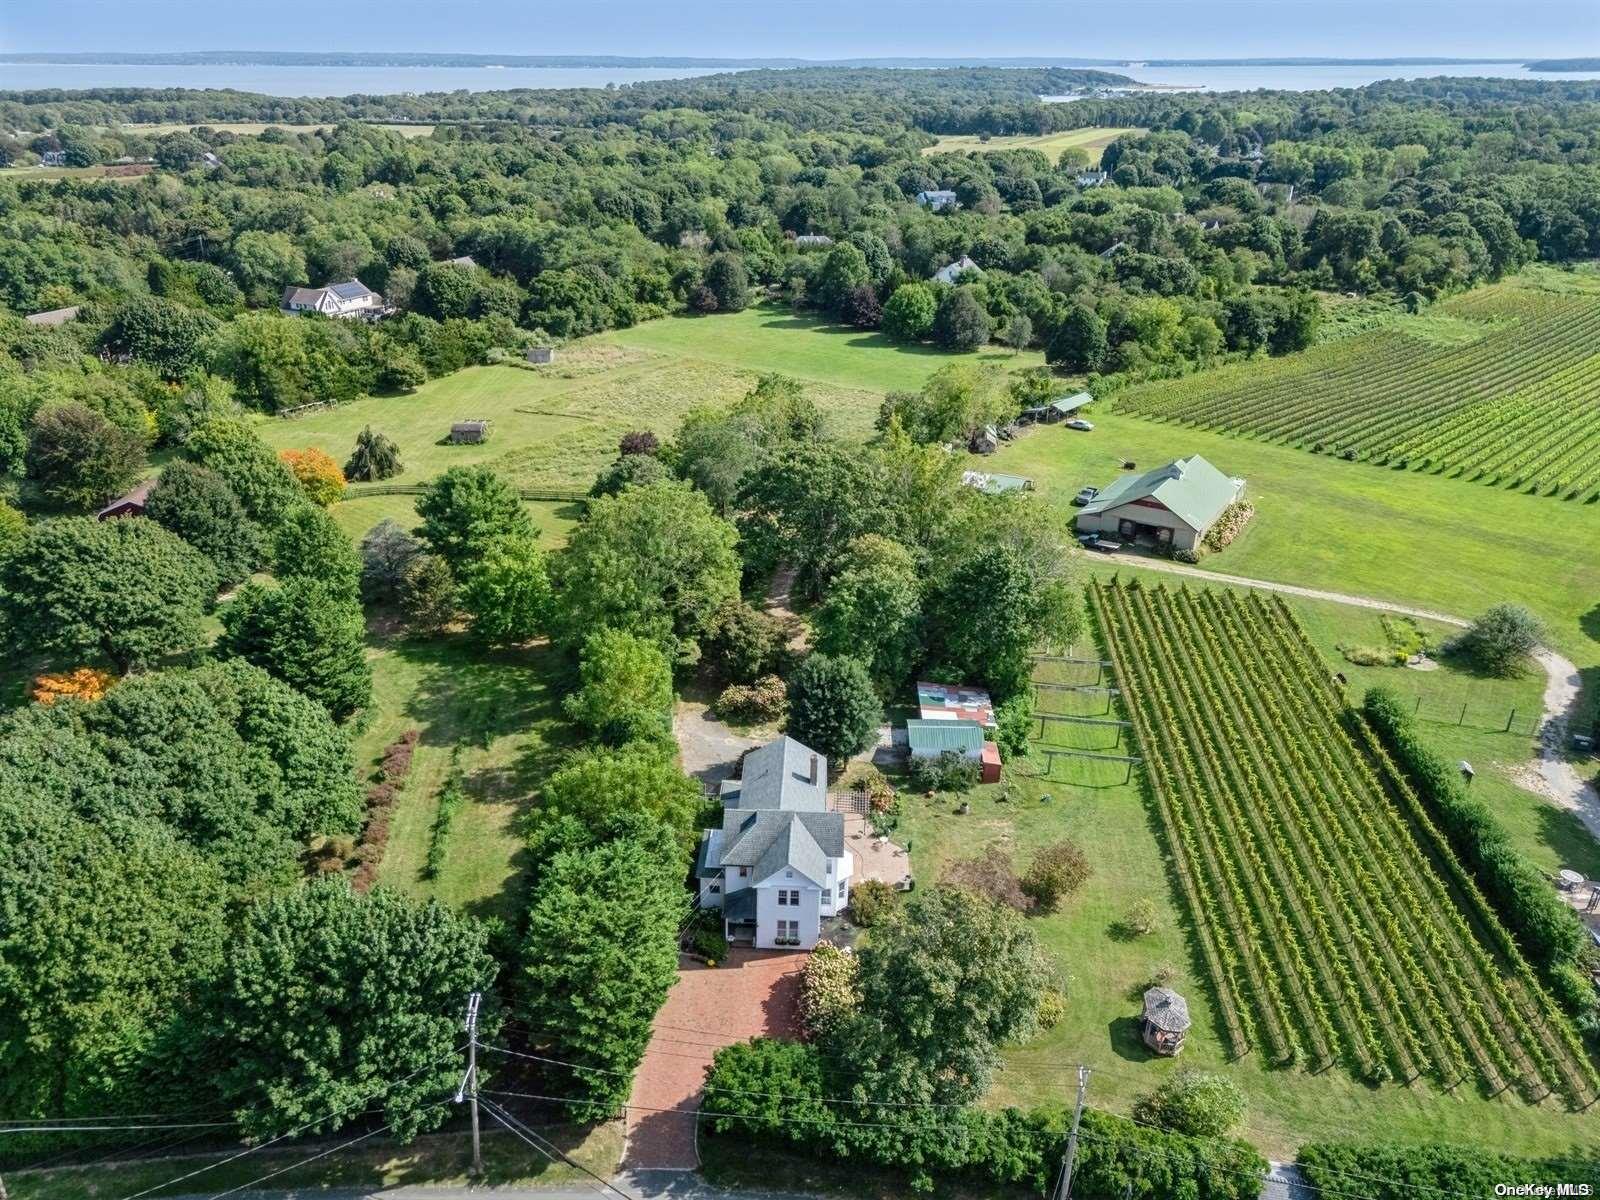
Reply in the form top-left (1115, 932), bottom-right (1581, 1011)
top-left (0, 0), bottom-right (1600, 59)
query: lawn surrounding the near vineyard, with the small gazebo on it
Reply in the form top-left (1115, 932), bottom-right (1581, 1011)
top-left (901, 581), bottom-right (1600, 1157)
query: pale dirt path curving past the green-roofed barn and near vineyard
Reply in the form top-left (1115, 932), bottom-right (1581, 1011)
top-left (1106, 554), bottom-right (1600, 840)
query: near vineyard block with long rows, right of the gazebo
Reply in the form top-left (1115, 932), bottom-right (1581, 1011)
top-left (1091, 582), bottom-right (1600, 1109)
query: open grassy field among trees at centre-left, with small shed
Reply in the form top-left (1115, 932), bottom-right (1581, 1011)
top-left (258, 306), bottom-right (1043, 488)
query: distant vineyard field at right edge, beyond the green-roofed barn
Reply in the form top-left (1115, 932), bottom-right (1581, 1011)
top-left (1117, 282), bottom-right (1600, 499)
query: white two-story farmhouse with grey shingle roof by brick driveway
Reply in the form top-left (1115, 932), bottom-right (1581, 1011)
top-left (694, 738), bottom-right (851, 950)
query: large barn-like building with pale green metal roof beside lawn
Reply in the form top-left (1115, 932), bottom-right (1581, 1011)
top-left (1078, 454), bottom-right (1245, 550)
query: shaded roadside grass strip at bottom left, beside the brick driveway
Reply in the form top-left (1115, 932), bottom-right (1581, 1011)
top-left (21, 1118), bottom-right (622, 1200)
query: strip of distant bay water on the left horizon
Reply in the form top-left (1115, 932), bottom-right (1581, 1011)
top-left (0, 56), bottom-right (725, 96)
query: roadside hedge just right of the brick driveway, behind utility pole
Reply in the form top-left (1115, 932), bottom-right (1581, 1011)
top-left (701, 1038), bottom-right (1267, 1200)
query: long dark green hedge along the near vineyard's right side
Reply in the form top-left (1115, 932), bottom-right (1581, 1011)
top-left (1362, 688), bottom-right (1592, 979)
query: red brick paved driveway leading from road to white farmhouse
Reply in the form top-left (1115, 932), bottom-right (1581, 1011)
top-left (622, 949), bottom-right (806, 1171)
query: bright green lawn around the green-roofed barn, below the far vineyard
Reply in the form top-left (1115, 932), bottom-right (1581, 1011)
top-left (974, 406), bottom-right (1600, 674)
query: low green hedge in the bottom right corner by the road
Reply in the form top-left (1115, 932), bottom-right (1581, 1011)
top-left (1299, 1142), bottom-right (1600, 1200)
